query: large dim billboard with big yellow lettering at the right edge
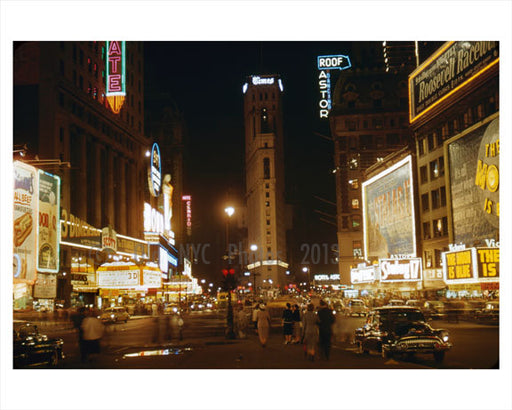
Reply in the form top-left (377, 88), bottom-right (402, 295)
top-left (447, 118), bottom-right (500, 244)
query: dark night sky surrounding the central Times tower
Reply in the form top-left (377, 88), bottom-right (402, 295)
top-left (144, 42), bottom-right (356, 278)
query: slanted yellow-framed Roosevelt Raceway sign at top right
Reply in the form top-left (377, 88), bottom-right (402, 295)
top-left (409, 41), bottom-right (499, 123)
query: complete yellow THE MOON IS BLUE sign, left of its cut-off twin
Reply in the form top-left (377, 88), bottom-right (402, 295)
top-left (441, 248), bottom-right (476, 284)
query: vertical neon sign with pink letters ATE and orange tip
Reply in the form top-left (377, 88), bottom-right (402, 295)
top-left (105, 41), bottom-right (126, 114)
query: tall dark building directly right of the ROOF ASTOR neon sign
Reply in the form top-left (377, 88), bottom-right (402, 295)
top-left (329, 42), bottom-right (414, 285)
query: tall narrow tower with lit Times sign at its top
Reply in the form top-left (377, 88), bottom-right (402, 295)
top-left (243, 75), bottom-right (288, 288)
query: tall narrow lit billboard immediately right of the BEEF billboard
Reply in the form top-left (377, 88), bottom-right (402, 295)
top-left (37, 170), bottom-right (60, 273)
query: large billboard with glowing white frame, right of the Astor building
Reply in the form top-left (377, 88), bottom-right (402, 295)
top-left (362, 155), bottom-right (416, 259)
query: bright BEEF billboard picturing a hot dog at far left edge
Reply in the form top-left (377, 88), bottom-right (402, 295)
top-left (13, 161), bottom-right (39, 284)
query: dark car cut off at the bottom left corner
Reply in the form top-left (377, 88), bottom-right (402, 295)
top-left (13, 320), bottom-right (64, 369)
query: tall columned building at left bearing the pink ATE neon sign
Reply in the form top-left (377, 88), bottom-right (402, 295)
top-left (14, 41), bottom-right (151, 305)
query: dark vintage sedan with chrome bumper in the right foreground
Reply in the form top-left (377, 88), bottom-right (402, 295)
top-left (355, 306), bottom-right (452, 362)
